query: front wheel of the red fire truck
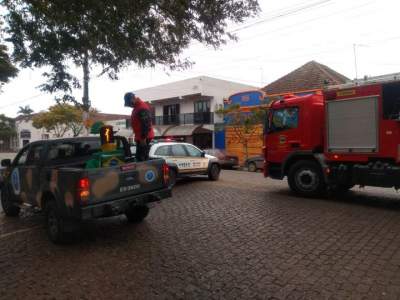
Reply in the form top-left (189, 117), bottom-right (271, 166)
top-left (288, 160), bottom-right (325, 197)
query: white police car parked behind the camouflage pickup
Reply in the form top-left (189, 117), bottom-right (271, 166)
top-left (149, 142), bottom-right (221, 184)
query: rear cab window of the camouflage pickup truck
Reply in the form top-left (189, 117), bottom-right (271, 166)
top-left (48, 141), bottom-right (100, 160)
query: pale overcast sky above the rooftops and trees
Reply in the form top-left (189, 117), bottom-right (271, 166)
top-left (0, 0), bottom-right (400, 117)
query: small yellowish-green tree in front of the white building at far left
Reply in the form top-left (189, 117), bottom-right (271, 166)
top-left (32, 103), bottom-right (84, 137)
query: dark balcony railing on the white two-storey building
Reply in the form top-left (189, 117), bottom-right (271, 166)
top-left (153, 112), bottom-right (214, 125)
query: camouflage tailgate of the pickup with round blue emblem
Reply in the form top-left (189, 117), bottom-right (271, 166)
top-left (86, 159), bottom-right (166, 204)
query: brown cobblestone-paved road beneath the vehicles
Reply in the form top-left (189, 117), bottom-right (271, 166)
top-left (0, 171), bottom-right (400, 299)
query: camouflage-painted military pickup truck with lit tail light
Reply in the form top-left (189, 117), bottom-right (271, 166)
top-left (0, 137), bottom-right (171, 243)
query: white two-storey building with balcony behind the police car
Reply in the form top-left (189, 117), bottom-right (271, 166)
top-left (134, 76), bottom-right (257, 149)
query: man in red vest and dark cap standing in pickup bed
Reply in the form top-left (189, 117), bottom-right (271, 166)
top-left (124, 93), bottom-right (154, 161)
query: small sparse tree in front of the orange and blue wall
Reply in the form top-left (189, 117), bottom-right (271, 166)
top-left (216, 104), bottom-right (267, 163)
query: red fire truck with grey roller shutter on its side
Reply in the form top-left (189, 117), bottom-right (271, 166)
top-left (264, 74), bottom-right (400, 196)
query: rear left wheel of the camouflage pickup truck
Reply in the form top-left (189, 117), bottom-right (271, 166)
top-left (46, 201), bottom-right (66, 244)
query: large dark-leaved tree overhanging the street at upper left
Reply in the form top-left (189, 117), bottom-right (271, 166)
top-left (0, 0), bottom-right (259, 111)
